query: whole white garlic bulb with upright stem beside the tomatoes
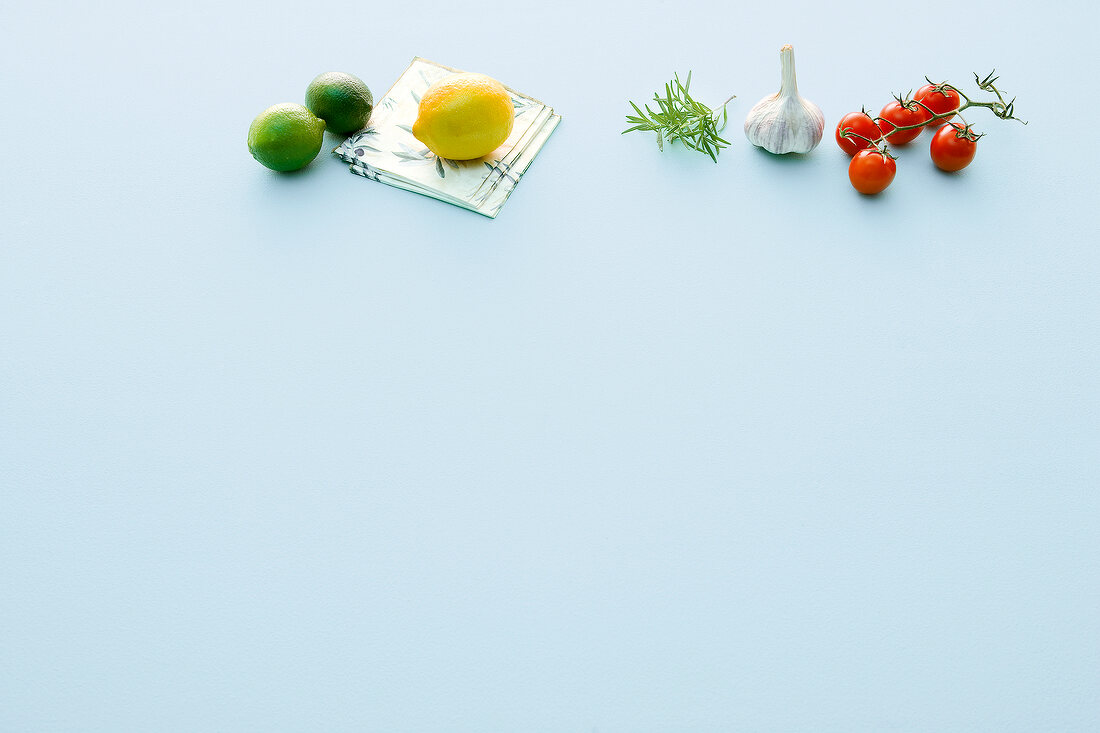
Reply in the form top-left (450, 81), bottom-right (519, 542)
top-left (745, 44), bottom-right (825, 154)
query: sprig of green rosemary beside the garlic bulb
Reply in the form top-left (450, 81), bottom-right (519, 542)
top-left (623, 72), bottom-right (733, 163)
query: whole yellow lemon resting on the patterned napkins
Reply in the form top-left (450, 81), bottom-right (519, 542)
top-left (413, 74), bottom-right (515, 161)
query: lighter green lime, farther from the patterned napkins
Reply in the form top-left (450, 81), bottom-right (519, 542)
top-left (249, 102), bottom-right (325, 171)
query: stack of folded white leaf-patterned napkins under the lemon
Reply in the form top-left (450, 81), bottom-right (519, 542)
top-left (332, 56), bottom-right (561, 218)
